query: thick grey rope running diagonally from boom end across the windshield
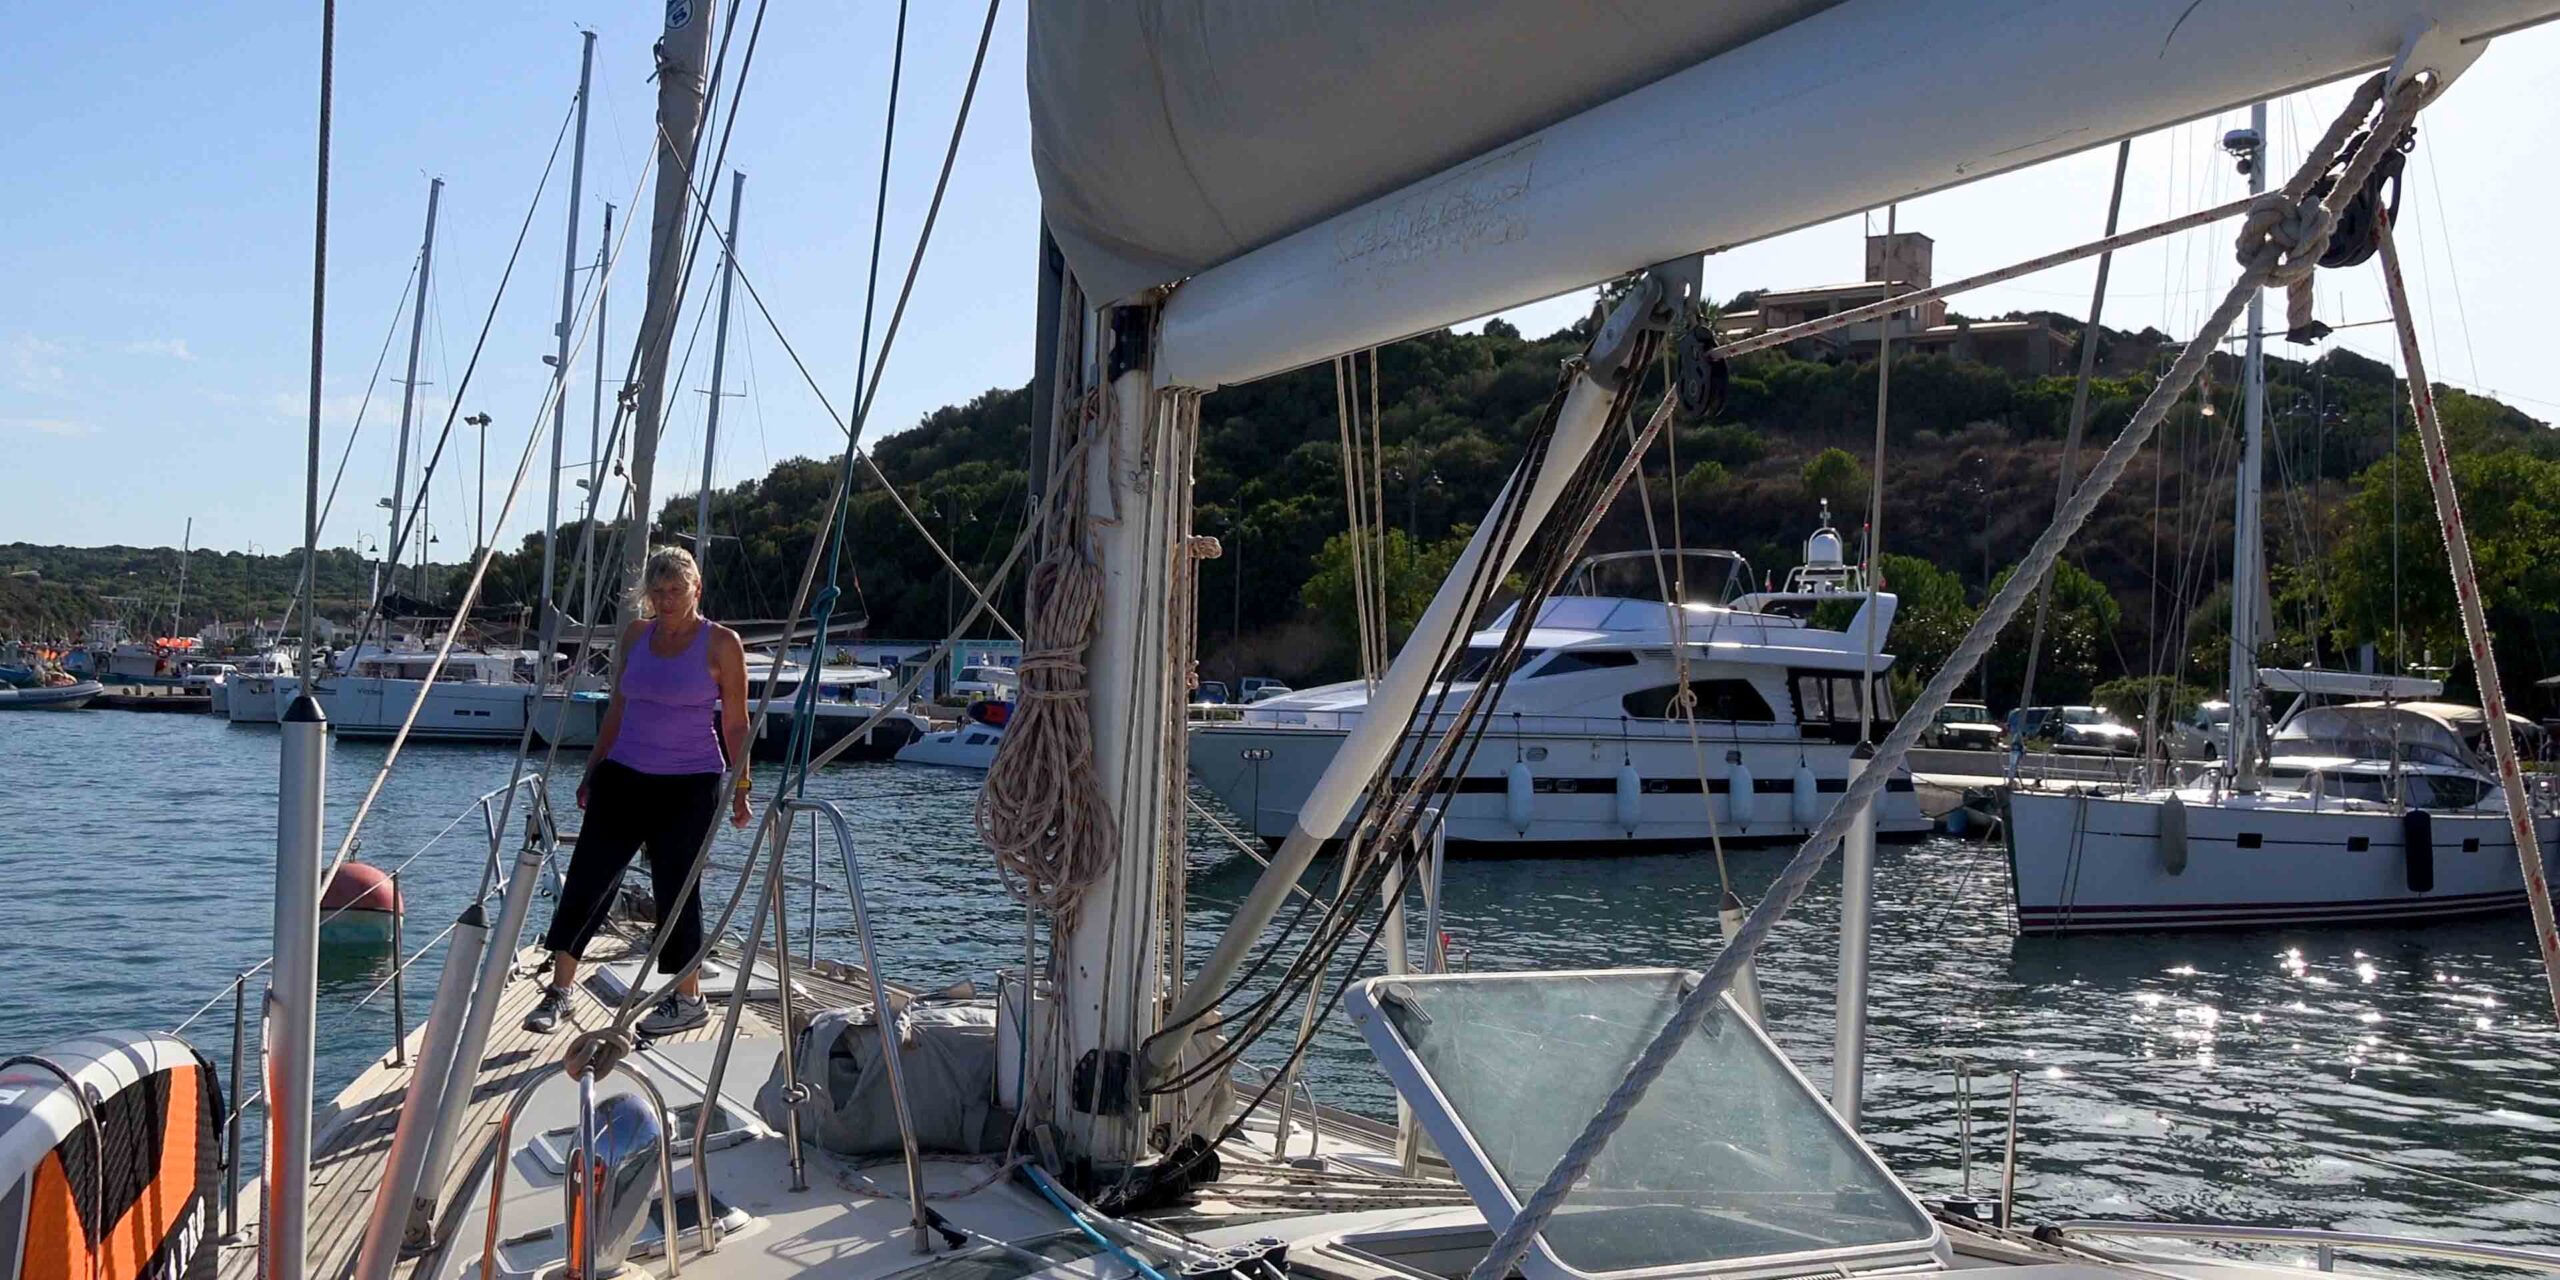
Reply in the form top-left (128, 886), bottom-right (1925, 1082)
top-left (1469, 74), bottom-right (2427, 1280)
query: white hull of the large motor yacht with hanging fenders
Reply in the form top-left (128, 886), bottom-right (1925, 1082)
top-left (1190, 717), bottom-right (1930, 850)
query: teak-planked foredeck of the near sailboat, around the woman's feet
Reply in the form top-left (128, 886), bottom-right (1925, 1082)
top-left (218, 940), bottom-right (870, 1280)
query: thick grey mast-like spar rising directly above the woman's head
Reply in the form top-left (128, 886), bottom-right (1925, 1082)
top-left (622, 0), bottom-right (719, 599)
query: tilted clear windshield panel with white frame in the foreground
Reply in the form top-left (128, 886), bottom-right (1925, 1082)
top-left (1354, 970), bottom-right (1935, 1280)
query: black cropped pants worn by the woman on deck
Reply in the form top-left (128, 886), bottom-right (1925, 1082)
top-left (543, 760), bottom-right (719, 973)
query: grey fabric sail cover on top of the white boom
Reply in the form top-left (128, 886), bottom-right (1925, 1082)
top-left (1029, 0), bottom-right (1838, 300)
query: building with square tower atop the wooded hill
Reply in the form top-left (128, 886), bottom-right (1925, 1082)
top-left (1718, 230), bottom-right (2074, 376)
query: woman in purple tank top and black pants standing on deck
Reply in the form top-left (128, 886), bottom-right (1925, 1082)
top-left (525, 548), bottom-right (748, 1037)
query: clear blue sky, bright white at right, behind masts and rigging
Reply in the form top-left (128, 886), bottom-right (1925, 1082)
top-left (0, 0), bottom-right (2560, 558)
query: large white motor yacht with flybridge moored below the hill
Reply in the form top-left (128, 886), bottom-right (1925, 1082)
top-left (1190, 520), bottom-right (1928, 852)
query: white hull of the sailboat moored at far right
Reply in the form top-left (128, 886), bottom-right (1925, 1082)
top-left (2007, 791), bottom-right (2560, 934)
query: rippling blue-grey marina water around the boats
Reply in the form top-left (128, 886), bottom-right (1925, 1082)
top-left (0, 712), bottom-right (2560, 1247)
